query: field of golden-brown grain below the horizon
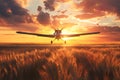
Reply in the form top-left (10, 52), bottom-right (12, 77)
top-left (0, 45), bottom-right (120, 80)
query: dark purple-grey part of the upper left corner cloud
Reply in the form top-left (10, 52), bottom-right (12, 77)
top-left (0, 0), bottom-right (32, 24)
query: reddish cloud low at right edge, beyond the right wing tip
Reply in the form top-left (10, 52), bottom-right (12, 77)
top-left (88, 26), bottom-right (120, 41)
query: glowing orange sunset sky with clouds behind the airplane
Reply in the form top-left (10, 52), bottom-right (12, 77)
top-left (0, 0), bottom-right (120, 44)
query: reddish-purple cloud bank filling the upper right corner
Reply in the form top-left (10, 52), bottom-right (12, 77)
top-left (76, 0), bottom-right (120, 18)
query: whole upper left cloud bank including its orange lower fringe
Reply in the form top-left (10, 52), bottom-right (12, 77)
top-left (0, 0), bottom-right (38, 31)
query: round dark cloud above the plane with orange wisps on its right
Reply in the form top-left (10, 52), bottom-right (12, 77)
top-left (37, 6), bottom-right (68, 27)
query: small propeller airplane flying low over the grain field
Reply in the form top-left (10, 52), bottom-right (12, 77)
top-left (16, 29), bottom-right (100, 44)
